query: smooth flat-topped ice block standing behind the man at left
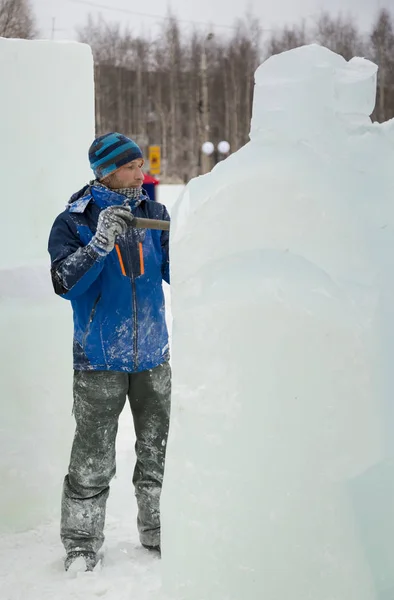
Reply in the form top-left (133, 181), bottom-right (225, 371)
top-left (0, 39), bottom-right (94, 532)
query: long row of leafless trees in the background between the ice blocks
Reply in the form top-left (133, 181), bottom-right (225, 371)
top-left (77, 9), bottom-right (394, 179)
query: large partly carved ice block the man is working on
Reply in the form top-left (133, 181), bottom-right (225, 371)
top-left (162, 45), bottom-right (394, 600)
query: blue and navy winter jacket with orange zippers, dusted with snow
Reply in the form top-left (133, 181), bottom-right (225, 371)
top-left (48, 185), bottom-right (170, 373)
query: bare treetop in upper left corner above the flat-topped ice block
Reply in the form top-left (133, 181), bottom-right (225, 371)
top-left (0, 0), bottom-right (37, 39)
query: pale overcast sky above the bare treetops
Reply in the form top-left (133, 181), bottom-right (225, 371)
top-left (32, 0), bottom-right (394, 39)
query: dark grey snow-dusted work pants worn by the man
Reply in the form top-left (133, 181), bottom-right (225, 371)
top-left (61, 363), bottom-right (171, 552)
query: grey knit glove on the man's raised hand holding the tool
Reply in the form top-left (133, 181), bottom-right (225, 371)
top-left (90, 206), bottom-right (134, 254)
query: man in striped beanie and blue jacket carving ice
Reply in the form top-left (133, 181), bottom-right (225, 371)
top-left (48, 133), bottom-right (171, 570)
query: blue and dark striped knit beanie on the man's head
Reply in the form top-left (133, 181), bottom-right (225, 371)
top-left (89, 133), bottom-right (142, 179)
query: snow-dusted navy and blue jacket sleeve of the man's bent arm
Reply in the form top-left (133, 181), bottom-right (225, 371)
top-left (48, 213), bottom-right (106, 300)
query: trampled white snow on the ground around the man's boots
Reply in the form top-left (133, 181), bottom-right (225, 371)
top-left (0, 186), bottom-right (183, 600)
